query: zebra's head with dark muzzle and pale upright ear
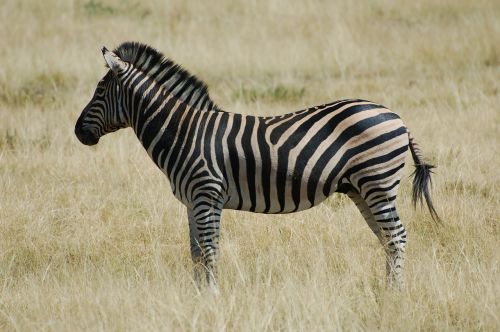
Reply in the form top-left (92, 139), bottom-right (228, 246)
top-left (75, 47), bottom-right (130, 145)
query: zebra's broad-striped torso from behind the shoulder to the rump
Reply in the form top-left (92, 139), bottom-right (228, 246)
top-left (219, 100), bottom-right (408, 213)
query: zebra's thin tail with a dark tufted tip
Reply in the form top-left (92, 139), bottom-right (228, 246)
top-left (408, 131), bottom-right (441, 222)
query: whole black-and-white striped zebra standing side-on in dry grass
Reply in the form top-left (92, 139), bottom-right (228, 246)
top-left (75, 42), bottom-right (438, 289)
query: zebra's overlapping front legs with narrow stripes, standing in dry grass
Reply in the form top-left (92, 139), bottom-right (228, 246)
top-left (188, 202), bottom-right (222, 292)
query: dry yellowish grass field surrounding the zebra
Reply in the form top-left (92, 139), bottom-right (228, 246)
top-left (0, 0), bottom-right (500, 331)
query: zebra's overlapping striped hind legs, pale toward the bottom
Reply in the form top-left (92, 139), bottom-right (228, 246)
top-left (347, 189), bottom-right (406, 288)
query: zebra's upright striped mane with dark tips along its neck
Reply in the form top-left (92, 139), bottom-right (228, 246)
top-left (113, 42), bottom-right (219, 110)
